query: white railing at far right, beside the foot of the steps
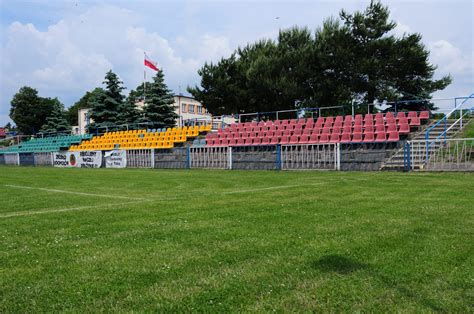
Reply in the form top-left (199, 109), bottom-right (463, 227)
top-left (409, 138), bottom-right (474, 171)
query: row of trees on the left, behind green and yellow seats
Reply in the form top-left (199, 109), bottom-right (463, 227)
top-left (10, 71), bottom-right (178, 134)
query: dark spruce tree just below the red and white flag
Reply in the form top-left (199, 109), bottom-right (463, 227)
top-left (144, 71), bottom-right (178, 128)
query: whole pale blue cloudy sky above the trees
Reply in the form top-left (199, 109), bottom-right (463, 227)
top-left (0, 0), bottom-right (474, 126)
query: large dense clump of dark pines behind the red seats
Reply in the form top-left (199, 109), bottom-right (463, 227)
top-left (188, 1), bottom-right (451, 115)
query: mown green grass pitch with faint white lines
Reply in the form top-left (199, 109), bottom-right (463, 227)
top-left (0, 167), bottom-right (474, 313)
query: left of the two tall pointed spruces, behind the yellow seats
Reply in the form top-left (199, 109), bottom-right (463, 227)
top-left (91, 70), bottom-right (125, 126)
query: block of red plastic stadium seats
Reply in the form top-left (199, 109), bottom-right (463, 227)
top-left (206, 111), bottom-right (429, 146)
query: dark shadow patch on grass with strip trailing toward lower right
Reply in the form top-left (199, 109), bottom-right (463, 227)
top-left (310, 254), bottom-right (445, 311)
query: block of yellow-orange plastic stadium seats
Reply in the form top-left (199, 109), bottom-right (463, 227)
top-left (70, 125), bottom-right (211, 151)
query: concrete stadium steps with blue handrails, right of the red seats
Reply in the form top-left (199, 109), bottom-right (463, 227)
top-left (380, 119), bottom-right (470, 171)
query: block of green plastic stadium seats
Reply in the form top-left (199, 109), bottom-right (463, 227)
top-left (1, 134), bottom-right (92, 153)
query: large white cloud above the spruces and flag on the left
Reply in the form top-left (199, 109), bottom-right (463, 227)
top-left (0, 5), bottom-right (231, 122)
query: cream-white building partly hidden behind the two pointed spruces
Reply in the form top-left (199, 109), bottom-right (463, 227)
top-left (73, 95), bottom-right (237, 134)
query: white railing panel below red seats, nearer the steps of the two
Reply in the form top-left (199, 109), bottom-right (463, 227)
top-left (281, 144), bottom-right (340, 170)
